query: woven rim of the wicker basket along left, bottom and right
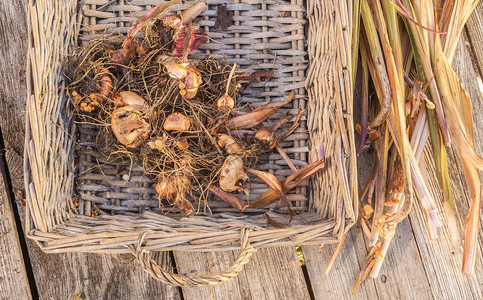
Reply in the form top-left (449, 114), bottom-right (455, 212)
top-left (24, 0), bottom-right (358, 253)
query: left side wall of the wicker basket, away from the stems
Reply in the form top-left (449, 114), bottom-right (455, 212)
top-left (24, 0), bottom-right (77, 231)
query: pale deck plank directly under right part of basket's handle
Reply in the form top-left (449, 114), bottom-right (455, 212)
top-left (174, 247), bottom-right (310, 300)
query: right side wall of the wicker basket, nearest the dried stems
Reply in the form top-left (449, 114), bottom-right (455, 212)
top-left (306, 0), bottom-right (358, 232)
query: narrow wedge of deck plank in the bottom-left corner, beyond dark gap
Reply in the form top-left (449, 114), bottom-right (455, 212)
top-left (0, 168), bottom-right (32, 299)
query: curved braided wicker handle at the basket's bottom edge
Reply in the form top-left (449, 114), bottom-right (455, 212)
top-left (128, 229), bottom-right (257, 287)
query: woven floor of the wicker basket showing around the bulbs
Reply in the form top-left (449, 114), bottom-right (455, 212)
top-left (77, 0), bottom-right (309, 215)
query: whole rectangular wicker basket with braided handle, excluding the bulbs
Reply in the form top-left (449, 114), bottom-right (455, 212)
top-left (25, 0), bottom-right (358, 286)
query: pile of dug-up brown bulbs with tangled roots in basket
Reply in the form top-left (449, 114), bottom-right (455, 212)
top-left (64, 1), bottom-right (323, 221)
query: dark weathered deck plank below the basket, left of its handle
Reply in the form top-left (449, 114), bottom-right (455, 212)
top-left (29, 246), bottom-right (181, 300)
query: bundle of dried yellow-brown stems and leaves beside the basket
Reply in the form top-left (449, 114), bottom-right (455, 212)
top-left (346, 0), bottom-right (483, 288)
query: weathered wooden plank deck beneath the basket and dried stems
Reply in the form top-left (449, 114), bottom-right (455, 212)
top-left (0, 0), bottom-right (483, 300)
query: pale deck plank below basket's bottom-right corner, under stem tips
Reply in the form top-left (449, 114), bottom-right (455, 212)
top-left (302, 149), bottom-right (433, 299)
